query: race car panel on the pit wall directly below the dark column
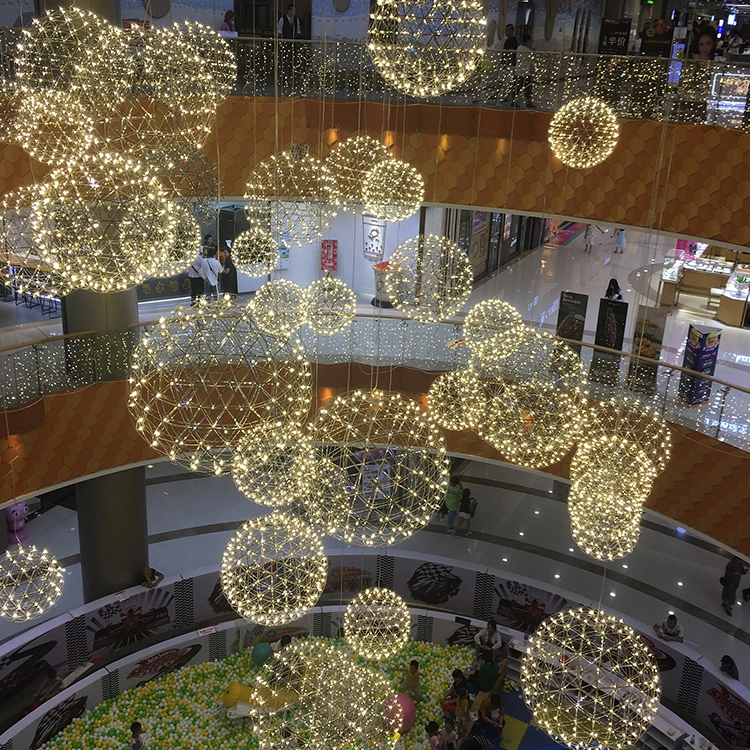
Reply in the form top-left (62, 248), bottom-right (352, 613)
top-left (86, 585), bottom-right (176, 661)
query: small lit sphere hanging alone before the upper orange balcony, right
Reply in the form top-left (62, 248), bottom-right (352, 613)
top-left (549, 96), bottom-right (620, 169)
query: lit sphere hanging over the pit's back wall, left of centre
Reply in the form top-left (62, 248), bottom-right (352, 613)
top-left (221, 512), bottom-right (328, 626)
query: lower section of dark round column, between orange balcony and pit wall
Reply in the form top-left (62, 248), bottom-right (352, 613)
top-left (76, 467), bottom-right (148, 602)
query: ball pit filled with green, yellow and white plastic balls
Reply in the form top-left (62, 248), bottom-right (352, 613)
top-left (38, 640), bottom-right (473, 750)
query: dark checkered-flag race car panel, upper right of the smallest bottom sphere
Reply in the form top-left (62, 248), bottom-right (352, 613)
top-left (393, 557), bottom-right (476, 616)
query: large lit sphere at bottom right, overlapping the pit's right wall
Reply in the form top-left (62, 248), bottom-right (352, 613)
top-left (521, 607), bottom-right (661, 750)
